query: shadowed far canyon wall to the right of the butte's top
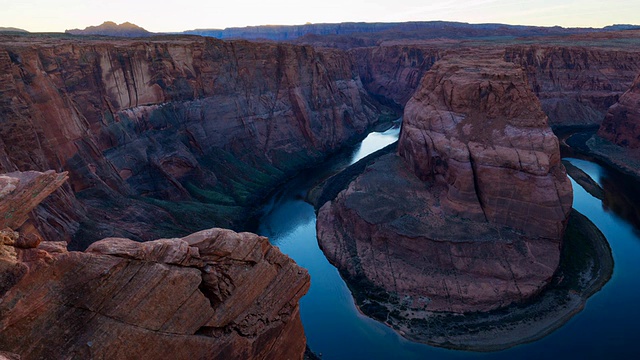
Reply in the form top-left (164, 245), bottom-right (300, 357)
top-left (505, 45), bottom-right (640, 126)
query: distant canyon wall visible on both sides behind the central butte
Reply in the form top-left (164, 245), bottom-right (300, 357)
top-left (349, 44), bottom-right (640, 126)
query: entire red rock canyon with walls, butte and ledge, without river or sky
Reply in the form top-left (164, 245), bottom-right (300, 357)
top-left (0, 23), bottom-right (640, 358)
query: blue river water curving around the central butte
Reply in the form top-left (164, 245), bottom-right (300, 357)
top-left (257, 127), bottom-right (640, 360)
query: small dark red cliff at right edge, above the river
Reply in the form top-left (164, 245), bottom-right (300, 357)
top-left (598, 76), bottom-right (640, 149)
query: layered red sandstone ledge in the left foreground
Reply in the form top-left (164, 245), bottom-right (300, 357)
top-left (0, 173), bottom-right (309, 359)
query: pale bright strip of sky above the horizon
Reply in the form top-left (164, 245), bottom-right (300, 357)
top-left (0, 0), bottom-right (640, 32)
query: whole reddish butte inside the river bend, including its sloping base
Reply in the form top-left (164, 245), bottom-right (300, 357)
top-left (317, 54), bottom-right (572, 317)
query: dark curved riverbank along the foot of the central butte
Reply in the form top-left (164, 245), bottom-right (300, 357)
top-left (332, 210), bottom-right (614, 352)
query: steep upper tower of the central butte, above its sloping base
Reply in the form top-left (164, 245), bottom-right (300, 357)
top-left (398, 54), bottom-right (572, 240)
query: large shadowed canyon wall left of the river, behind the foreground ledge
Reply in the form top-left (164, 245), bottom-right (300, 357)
top-left (0, 37), bottom-right (379, 248)
